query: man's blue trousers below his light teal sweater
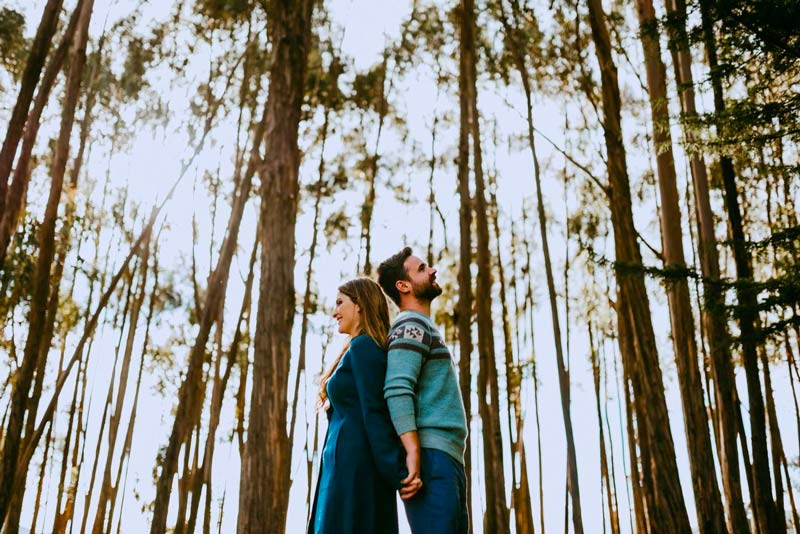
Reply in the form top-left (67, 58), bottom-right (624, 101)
top-left (403, 448), bottom-right (469, 534)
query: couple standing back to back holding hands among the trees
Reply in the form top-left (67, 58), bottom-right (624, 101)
top-left (308, 247), bottom-right (469, 534)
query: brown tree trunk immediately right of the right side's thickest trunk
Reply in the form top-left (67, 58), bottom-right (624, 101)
top-left (636, 0), bottom-right (727, 534)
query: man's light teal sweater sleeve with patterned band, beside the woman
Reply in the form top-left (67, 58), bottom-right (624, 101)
top-left (383, 317), bottom-right (431, 434)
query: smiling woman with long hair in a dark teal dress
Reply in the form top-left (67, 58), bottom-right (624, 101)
top-left (308, 278), bottom-right (406, 534)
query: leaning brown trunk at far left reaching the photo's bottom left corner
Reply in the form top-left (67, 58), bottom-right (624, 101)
top-left (0, 0), bottom-right (93, 521)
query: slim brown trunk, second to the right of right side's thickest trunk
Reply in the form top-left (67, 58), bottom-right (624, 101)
top-left (665, 0), bottom-right (750, 533)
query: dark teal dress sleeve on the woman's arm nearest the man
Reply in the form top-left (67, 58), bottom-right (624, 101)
top-left (350, 335), bottom-right (406, 489)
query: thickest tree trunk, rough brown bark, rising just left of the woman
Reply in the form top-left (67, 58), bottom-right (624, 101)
top-left (238, 0), bottom-right (314, 534)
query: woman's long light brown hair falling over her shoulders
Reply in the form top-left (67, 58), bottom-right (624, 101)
top-left (319, 277), bottom-right (389, 407)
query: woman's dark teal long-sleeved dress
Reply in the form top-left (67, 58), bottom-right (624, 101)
top-left (308, 334), bottom-right (407, 534)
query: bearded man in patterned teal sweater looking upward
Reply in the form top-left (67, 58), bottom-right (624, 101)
top-left (378, 247), bottom-right (469, 534)
